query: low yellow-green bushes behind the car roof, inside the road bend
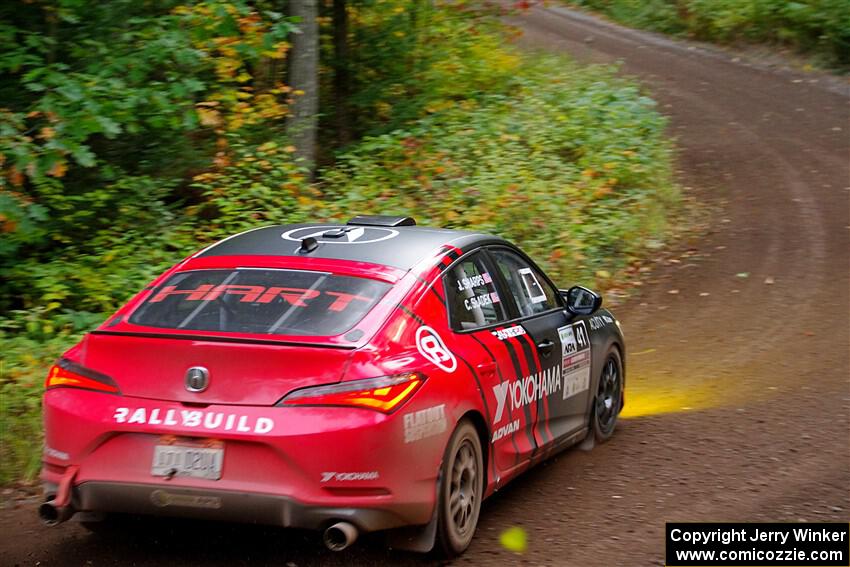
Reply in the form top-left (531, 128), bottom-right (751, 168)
top-left (323, 58), bottom-right (677, 285)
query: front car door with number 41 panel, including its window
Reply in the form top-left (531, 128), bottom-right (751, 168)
top-left (488, 247), bottom-right (590, 447)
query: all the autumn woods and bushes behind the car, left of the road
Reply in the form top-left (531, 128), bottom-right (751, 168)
top-left (0, 0), bottom-right (679, 483)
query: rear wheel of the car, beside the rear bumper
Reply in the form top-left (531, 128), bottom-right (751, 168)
top-left (435, 420), bottom-right (484, 558)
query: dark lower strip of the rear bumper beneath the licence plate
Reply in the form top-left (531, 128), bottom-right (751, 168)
top-left (58, 482), bottom-right (412, 532)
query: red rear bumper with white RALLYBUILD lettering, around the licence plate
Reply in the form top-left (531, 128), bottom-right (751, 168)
top-left (41, 388), bottom-right (451, 531)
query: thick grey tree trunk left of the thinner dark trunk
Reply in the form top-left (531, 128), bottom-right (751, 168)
top-left (287, 0), bottom-right (319, 170)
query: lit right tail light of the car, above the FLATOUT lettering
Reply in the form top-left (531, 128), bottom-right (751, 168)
top-left (278, 372), bottom-right (425, 413)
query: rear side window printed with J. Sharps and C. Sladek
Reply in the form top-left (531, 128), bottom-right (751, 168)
top-left (443, 253), bottom-right (507, 331)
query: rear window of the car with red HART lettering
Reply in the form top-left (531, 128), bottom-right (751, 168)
top-left (130, 268), bottom-right (390, 336)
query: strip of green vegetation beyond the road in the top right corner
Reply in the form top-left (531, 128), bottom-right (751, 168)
top-left (567, 0), bottom-right (850, 72)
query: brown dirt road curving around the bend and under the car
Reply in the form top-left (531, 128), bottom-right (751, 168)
top-left (0, 8), bottom-right (850, 567)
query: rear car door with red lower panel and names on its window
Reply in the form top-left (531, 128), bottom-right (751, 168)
top-left (443, 251), bottom-right (537, 481)
